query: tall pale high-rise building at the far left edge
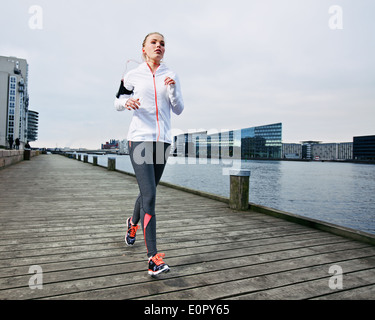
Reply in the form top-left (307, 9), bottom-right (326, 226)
top-left (0, 56), bottom-right (29, 149)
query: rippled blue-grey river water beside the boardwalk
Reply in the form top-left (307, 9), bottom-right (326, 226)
top-left (89, 156), bottom-right (375, 234)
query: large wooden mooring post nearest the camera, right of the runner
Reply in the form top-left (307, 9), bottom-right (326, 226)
top-left (229, 169), bottom-right (250, 211)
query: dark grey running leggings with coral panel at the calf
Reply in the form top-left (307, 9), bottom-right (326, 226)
top-left (129, 141), bottom-right (170, 257)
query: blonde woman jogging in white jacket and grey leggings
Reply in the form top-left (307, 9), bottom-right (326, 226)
top-left (115, 32), bottom-right (184, 276)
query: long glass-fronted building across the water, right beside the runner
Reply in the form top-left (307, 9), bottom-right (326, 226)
top-left (172, 123), bottom-right (282, 159)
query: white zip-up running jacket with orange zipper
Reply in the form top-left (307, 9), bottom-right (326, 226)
top-left (114, 62), bottom-right (184, 143)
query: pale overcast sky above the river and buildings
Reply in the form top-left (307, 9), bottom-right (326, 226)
top-left (0, 0), bottom-right (375, 149)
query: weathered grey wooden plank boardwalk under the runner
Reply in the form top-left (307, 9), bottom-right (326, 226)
top-left (0, 155), bottom-right (375, 300)
